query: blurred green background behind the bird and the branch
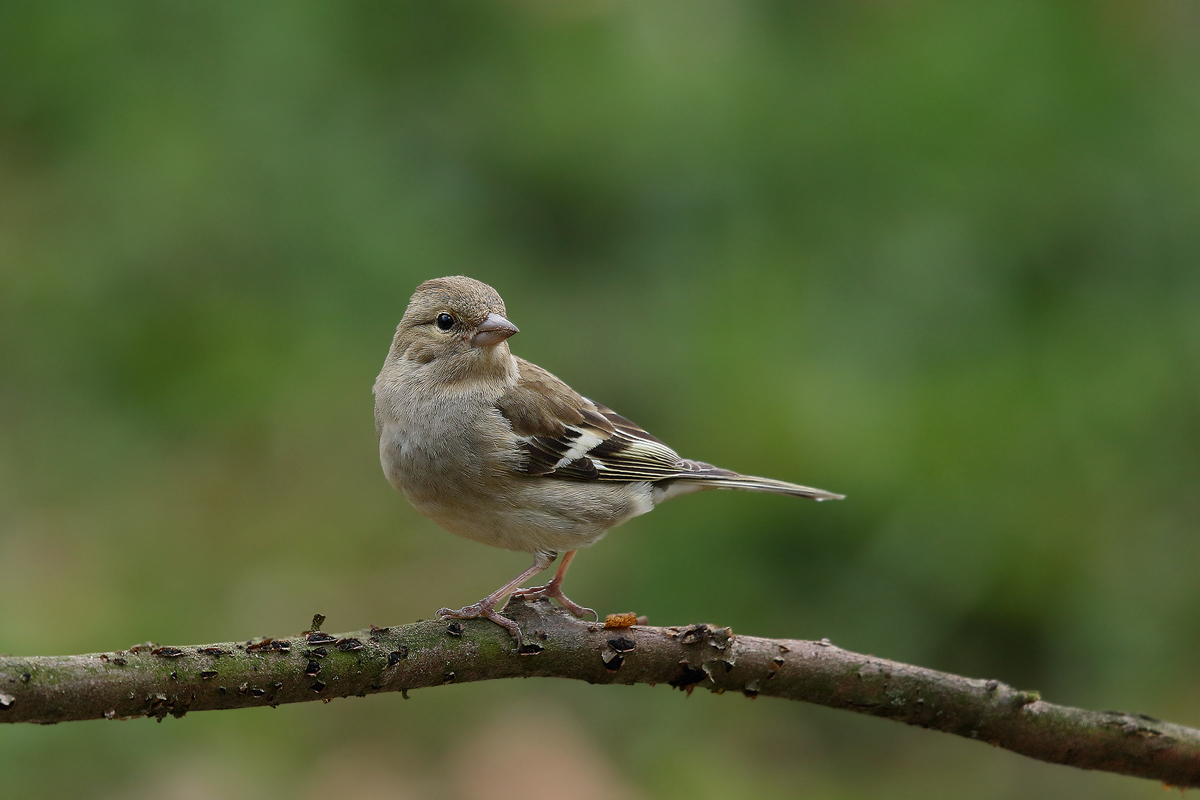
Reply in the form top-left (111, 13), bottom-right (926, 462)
top-left (0, 0), bottom-right (1200, 800)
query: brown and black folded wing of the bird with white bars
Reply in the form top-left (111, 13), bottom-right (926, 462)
top-left (496, 359), bottom-right (700, 481)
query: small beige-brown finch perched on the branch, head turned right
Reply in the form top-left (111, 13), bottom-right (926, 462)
top-left (373, 276), bottom-right (844, 643)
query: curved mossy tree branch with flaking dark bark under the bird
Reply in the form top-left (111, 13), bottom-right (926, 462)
top-left (0, 600), bottom-right (1200, 787)
